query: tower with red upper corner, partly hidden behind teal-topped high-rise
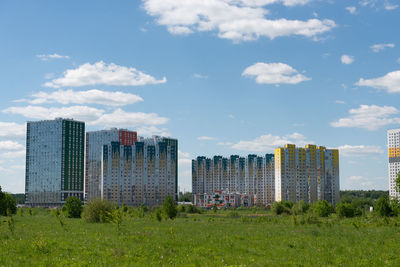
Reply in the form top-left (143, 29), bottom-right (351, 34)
top-left (85, 128), bottom-right (137, 201)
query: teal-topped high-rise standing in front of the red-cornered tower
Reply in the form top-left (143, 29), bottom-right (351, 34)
top-left (100, 136), bottom-right (178, 206)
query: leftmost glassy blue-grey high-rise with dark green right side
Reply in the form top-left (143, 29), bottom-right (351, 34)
top-left (25, 118), bottom-right (85, 206)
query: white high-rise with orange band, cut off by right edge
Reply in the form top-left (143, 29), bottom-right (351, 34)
top-left (387, 129), bottom-right (400, 198)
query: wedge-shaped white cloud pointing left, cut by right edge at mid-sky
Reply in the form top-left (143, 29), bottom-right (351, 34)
top-left (355, 70), bottom-right (400, 93)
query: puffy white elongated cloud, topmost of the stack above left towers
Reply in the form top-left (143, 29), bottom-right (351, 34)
top-left (44, 61), bottom-right (167, 88)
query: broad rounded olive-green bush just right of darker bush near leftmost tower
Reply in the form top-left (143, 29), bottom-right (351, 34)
top-left (82, 199), bottom-right (114, 223)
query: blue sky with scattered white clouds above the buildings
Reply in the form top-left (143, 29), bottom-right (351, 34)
top-left (0, 0), bottom-right (400, 192)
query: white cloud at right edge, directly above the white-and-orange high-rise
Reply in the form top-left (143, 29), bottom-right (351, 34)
top-left (331, 105), bottom-right (400, 131)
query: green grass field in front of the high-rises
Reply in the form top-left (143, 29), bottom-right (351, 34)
top-left (0, 209), bottom-right (400, 266)
